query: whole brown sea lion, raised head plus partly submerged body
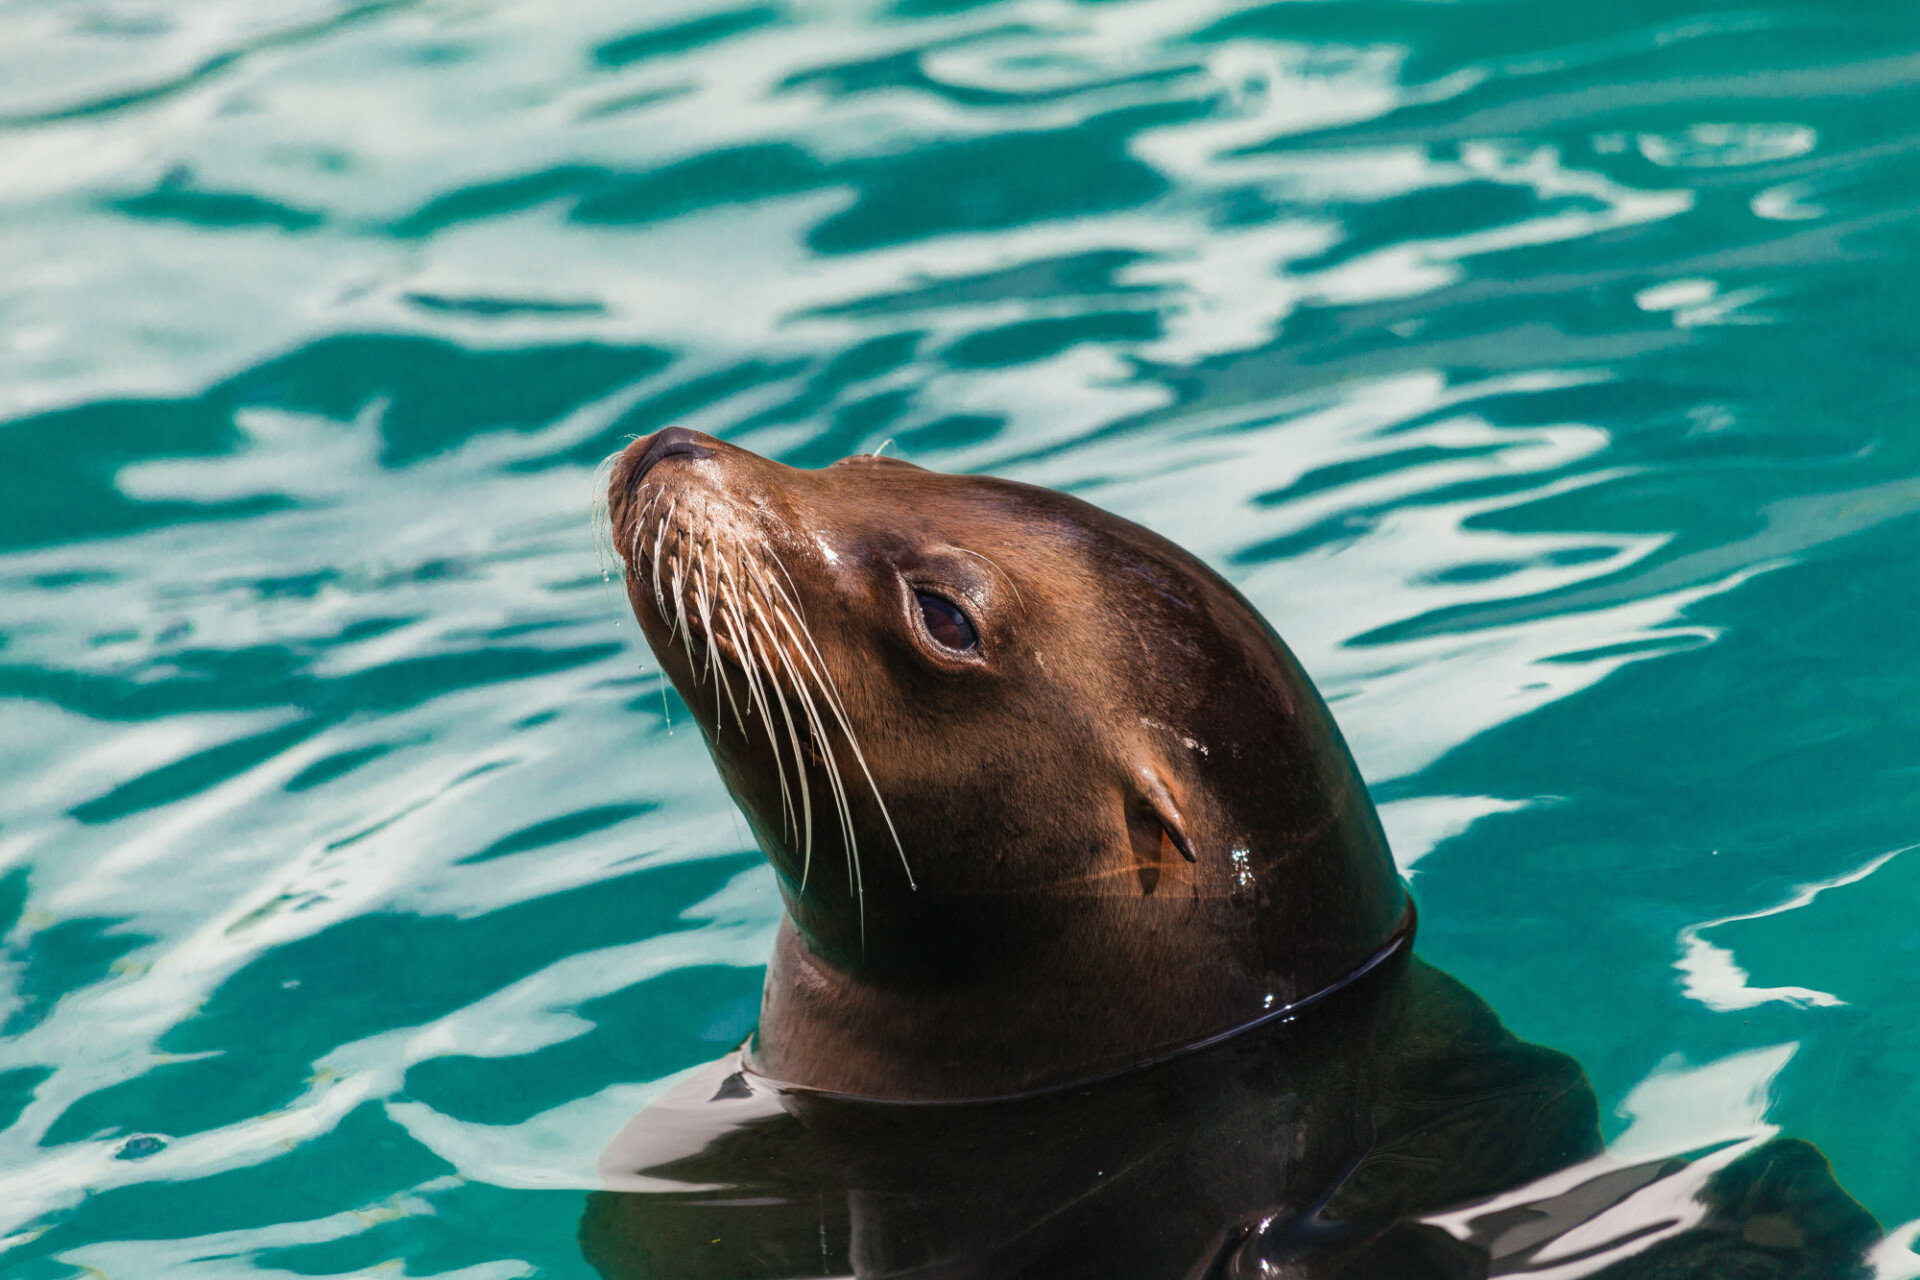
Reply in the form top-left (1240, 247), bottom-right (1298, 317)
top-left (582, 430), bottom-right (1874, 1276)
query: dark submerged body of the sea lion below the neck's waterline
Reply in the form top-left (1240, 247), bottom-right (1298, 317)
top-left (582, 954), bottom-right (1599, 1280)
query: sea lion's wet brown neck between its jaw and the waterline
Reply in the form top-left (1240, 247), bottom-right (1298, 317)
top-left (749, 771), bottom-right (1411, 1100)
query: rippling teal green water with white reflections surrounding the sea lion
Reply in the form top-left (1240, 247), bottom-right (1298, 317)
top-left (0, 0), bottom-right (1920, 1280)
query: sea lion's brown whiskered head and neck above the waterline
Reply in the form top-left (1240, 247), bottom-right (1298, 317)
top-left (609, 428), bottom-right (1405, 1092)
